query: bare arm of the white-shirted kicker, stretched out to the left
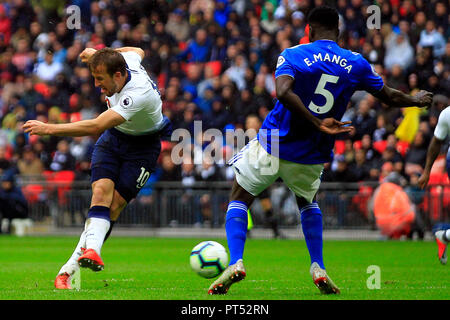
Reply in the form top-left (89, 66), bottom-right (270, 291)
top-left (23, 109), bottom-right (126, 137)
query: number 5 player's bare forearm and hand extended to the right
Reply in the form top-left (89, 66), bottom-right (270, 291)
top-left (372, 85), bottom-right (433, 108)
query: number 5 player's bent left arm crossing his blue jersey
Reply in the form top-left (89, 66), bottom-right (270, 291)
top-left (275, 75), bottom-right (354, 135)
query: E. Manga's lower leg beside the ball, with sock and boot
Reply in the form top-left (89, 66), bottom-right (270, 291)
top-left (208, 179), bottom-right (255, 294)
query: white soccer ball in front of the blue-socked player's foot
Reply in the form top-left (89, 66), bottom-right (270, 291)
top-left (190, 241), bottom-right (228, 279)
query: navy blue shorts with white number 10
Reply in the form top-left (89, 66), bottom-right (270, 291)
top-left (91, 128), bottom-right (161, 203)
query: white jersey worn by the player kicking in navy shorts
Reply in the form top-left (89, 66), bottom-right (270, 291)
top-left (106, 51), bottom-right (163, 135)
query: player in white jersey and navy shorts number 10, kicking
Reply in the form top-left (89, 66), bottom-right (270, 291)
top-left (24, 47), bottom-right (171, 289)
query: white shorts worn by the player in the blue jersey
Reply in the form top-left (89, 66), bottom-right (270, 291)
top-left (228, 139), bottom-right (323, 203)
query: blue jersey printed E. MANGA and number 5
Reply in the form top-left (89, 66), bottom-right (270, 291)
top-left (258, 40), bottom-right (383, 164)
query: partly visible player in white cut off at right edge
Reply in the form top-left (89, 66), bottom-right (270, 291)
top-left (419, 106), bottom-right (450, 264)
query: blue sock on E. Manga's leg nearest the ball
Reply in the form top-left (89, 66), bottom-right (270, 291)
top-left (225, 201), bottom-right (248, 265)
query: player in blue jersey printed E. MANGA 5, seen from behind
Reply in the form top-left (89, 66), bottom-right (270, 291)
top-left (208, 6), bottom-right (432, 294)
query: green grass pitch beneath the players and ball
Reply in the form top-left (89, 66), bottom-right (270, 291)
top-left (0, 236), bottom-right (450, 300)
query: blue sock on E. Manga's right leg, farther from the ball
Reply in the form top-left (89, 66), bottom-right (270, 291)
top-left (300, 202), bottom-right (325, 269)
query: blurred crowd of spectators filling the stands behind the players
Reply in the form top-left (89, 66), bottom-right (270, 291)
top-left (0, 0), bottom-right (450, 225)
